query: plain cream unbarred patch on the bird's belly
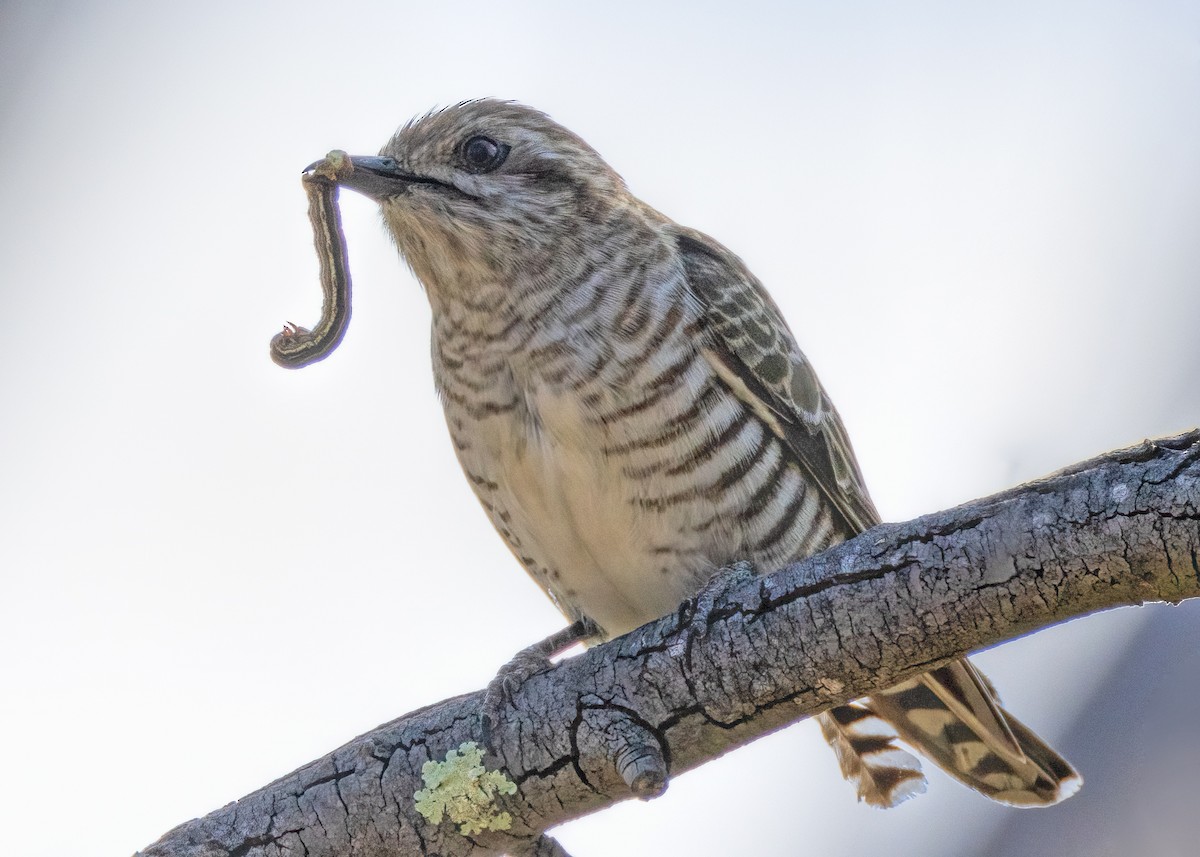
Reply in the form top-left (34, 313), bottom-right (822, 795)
top-left (460, 369), bottom-right (705, 636)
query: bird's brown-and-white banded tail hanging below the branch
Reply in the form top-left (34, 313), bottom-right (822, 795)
top-left (821, 660), bottom-right (1082, 807)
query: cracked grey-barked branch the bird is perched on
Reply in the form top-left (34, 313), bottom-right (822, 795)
top-left (139, 431), bottom-right (1200, 857)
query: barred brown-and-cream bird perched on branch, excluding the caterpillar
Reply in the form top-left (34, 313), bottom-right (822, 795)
top-left (341, 98), bottom-right (1081, 807)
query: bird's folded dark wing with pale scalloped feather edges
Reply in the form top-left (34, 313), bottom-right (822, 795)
top-left (677, 228), bottom-right (880, 538)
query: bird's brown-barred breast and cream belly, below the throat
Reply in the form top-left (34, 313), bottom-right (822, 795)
top-left (434, 220), bottom-right (838, 637)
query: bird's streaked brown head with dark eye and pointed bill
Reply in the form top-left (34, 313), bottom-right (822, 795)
top-left (333, 100), bottom-right (626, 294)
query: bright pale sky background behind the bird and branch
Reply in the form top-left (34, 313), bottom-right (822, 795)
top-left (0, 0), bottom-right (1200, 857)
